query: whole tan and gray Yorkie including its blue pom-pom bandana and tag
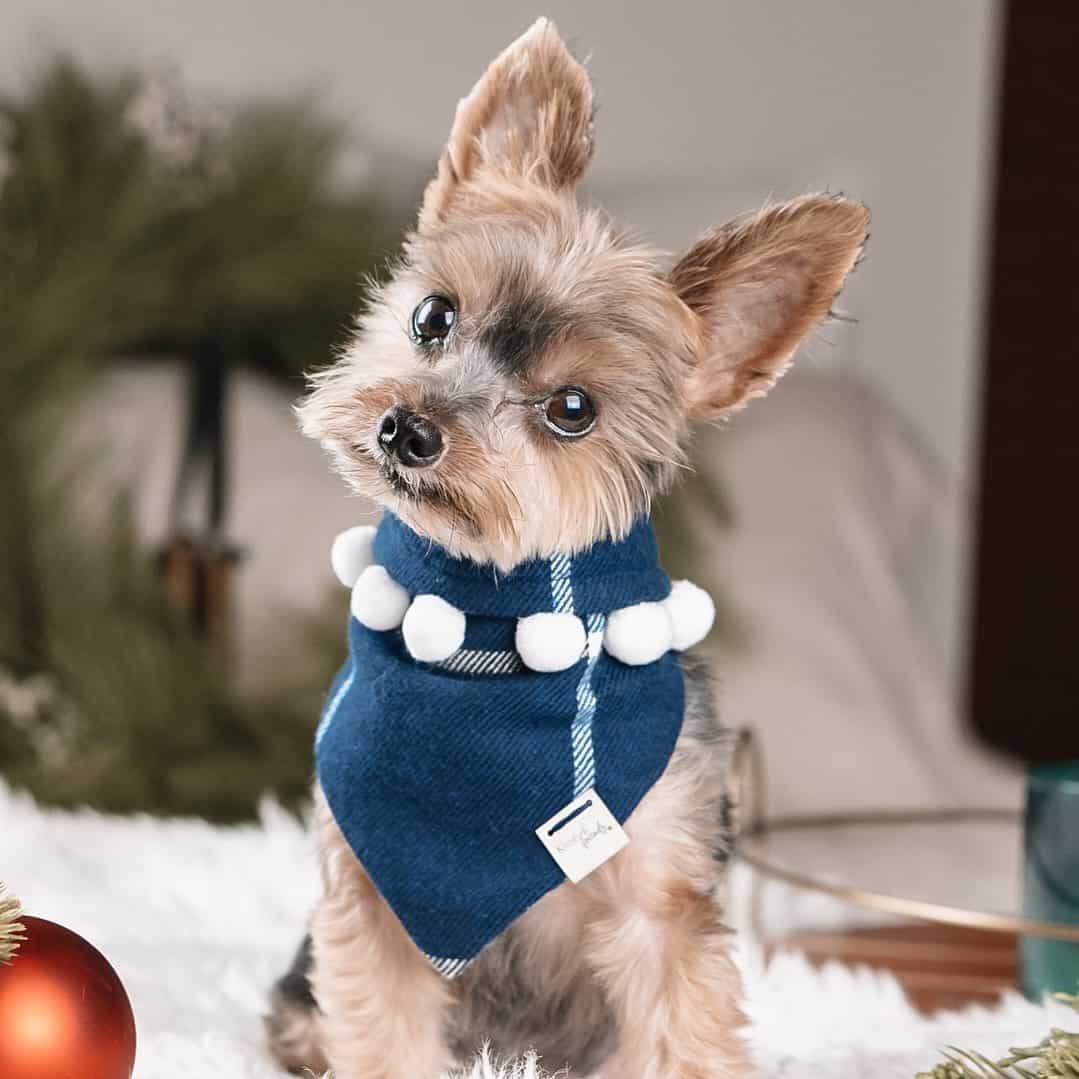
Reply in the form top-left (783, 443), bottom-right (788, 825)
top-left (269, 19), bottom-right (869, 1079)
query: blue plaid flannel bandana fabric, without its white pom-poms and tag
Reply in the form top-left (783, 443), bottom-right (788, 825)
top-left (315, 514), bottom-right (684, 976)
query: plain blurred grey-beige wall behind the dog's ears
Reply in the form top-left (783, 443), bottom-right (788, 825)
top-left (0, 0), bottom-right (998, 673)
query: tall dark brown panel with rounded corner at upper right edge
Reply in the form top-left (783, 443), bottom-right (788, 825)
top-left (969, 0), bottom-right (1079, 762)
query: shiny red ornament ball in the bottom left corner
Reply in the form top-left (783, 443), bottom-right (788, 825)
top-left (0, 917), bottom-right (135, 1079)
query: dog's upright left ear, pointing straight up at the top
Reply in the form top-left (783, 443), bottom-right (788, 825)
top-left (420, 18), bottom-right (592, 228)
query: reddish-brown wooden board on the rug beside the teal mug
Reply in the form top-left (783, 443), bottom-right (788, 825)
top-left (768, 925), bottom-right (1019, 1015)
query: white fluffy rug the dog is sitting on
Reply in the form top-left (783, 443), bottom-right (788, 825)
top-left (6, 784), bottom-right (1075, 1079)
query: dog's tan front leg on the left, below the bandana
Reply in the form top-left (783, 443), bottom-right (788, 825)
top-left (311, 795), bottom-right (450, 1079)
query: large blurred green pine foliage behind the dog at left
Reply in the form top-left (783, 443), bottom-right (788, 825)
top-left (0, 58), bottom-right (400, 820)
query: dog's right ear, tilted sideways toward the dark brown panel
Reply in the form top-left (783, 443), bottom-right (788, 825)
top-left (671, 195), bottom-right (869, 419)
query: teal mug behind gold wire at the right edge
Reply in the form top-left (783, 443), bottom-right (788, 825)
top-left (1022, 761), bottom-right (1079, 999)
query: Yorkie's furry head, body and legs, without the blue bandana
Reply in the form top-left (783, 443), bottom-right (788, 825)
top-left (269, 19), bottom-right (869, 1079)
